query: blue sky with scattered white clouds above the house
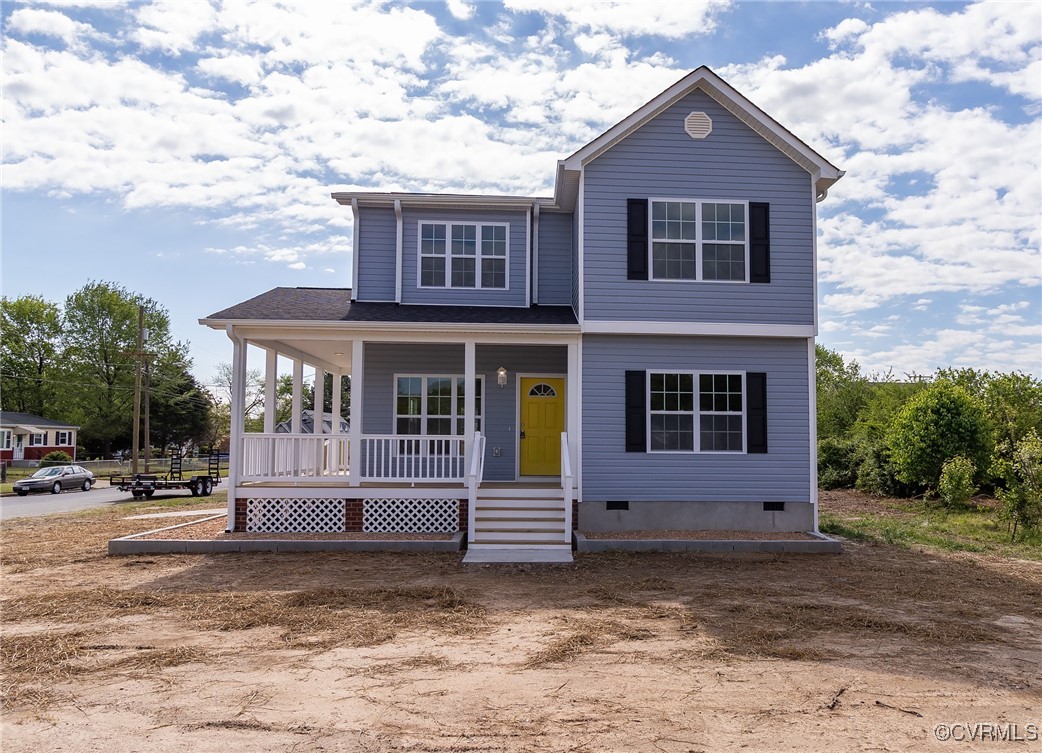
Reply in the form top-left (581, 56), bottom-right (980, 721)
top-left (0, 0), bottom-right (1042, 382)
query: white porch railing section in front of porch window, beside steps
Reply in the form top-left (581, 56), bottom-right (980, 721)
top-left (357, 434), bottom-right (466, 482)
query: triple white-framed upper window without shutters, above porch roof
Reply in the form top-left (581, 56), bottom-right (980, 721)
top-left (419, 222), bottom-right (510, 290)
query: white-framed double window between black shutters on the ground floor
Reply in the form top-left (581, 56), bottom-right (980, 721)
top-left (647, 371), bottom-right (746, 453)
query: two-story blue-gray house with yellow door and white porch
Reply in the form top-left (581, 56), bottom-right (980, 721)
top-left (201, 68), bottom-right (843, 556)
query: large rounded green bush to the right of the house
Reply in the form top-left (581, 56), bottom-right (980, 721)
top-left (886, 381), bottom-right (992, 490)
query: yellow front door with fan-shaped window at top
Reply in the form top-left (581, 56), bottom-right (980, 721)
top-left (519, 377), bottom-right (565, 476)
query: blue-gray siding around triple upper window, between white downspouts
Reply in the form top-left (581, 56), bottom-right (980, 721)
top-left (401, 209), bottom-right (528, 306)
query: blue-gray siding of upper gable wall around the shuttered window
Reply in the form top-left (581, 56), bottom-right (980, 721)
top-left (584, 91), bottom-right (815, 324)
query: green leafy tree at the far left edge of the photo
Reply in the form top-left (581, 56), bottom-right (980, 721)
top-left (0, 296), bottom-right (63, 418)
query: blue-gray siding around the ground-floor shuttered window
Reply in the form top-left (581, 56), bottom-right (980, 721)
top-left (582, 335), bottom-right (812, 502)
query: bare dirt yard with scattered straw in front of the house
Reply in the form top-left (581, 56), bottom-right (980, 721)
top-left (2, 497), bottom-right (1042, 753)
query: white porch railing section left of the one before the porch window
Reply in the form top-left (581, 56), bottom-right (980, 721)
top-left (241, 433), bottom-right (350, 481)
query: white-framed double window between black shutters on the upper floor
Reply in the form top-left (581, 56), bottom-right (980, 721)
top-left (648, 199), bottom-right (749, 282)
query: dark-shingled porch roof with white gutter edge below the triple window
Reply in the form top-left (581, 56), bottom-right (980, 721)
top-left (199, 287), bottom-right (578, 331)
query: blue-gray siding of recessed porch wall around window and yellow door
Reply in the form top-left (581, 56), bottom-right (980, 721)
top-left (362, 343), bottom-right (568, 481)
